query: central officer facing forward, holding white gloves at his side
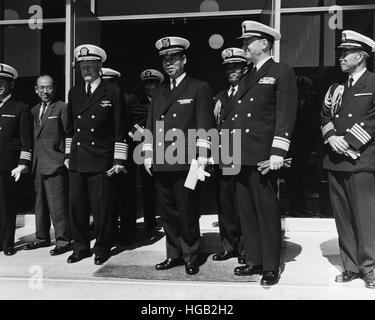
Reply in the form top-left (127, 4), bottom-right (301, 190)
top-left (143, 37), bottom-right (214, 275)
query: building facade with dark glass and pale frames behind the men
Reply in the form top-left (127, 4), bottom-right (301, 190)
top-left (0, 0), bottom-right (375, 216)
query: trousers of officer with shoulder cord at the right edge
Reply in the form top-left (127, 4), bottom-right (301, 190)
top-left (328, 171), bottom-right (375, 275)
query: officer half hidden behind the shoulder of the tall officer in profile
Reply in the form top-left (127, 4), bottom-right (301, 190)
top-left (212, 48), bottom-right (247, 264)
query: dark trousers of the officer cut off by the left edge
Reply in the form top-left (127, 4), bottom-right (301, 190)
top-left (0, 171), bottom-right (17, 250)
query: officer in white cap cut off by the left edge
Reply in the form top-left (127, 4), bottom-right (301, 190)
top-left (0, 63), bottom-right (32, 256)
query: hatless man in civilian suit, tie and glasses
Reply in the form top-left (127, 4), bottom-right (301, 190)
top-left (24, 75), bottom-right (70, 256)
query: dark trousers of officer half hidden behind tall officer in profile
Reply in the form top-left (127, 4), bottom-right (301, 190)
top-left (217, 172), bottom-right (242, 253)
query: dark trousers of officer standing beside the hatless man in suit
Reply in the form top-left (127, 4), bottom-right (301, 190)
top-left (69, 171), bottom-right (115, 255)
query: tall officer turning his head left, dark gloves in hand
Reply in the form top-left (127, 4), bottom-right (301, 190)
top-left (234, 21), bottom-right (297, 285)
